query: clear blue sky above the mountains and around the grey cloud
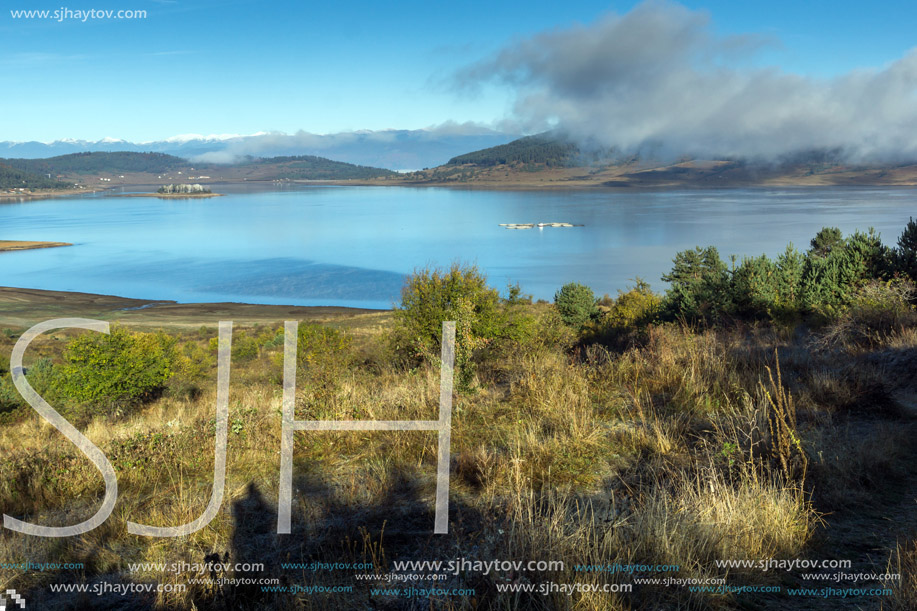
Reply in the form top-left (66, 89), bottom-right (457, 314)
top-left (0, 0), bottom-right (917, 141)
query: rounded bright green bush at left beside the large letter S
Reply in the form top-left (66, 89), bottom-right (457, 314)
top-left (56, 327), bottom-right (176, 415)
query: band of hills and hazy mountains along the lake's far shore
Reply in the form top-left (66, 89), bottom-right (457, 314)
top-left (10, 130), bottom-right (917, 192)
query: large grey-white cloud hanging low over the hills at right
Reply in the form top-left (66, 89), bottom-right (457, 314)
top-left (456, 1), bottom-right (917, 160)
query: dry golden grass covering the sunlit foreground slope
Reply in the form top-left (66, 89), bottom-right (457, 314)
top-left (0, 310), bottom-right (913, 610)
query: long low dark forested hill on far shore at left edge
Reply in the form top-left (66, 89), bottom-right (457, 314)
top-left (0, 152), bottom-right (188, 175)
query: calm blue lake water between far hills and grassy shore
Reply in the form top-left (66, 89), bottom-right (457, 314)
top-left (0, 186), bottom-right (917, 308)
